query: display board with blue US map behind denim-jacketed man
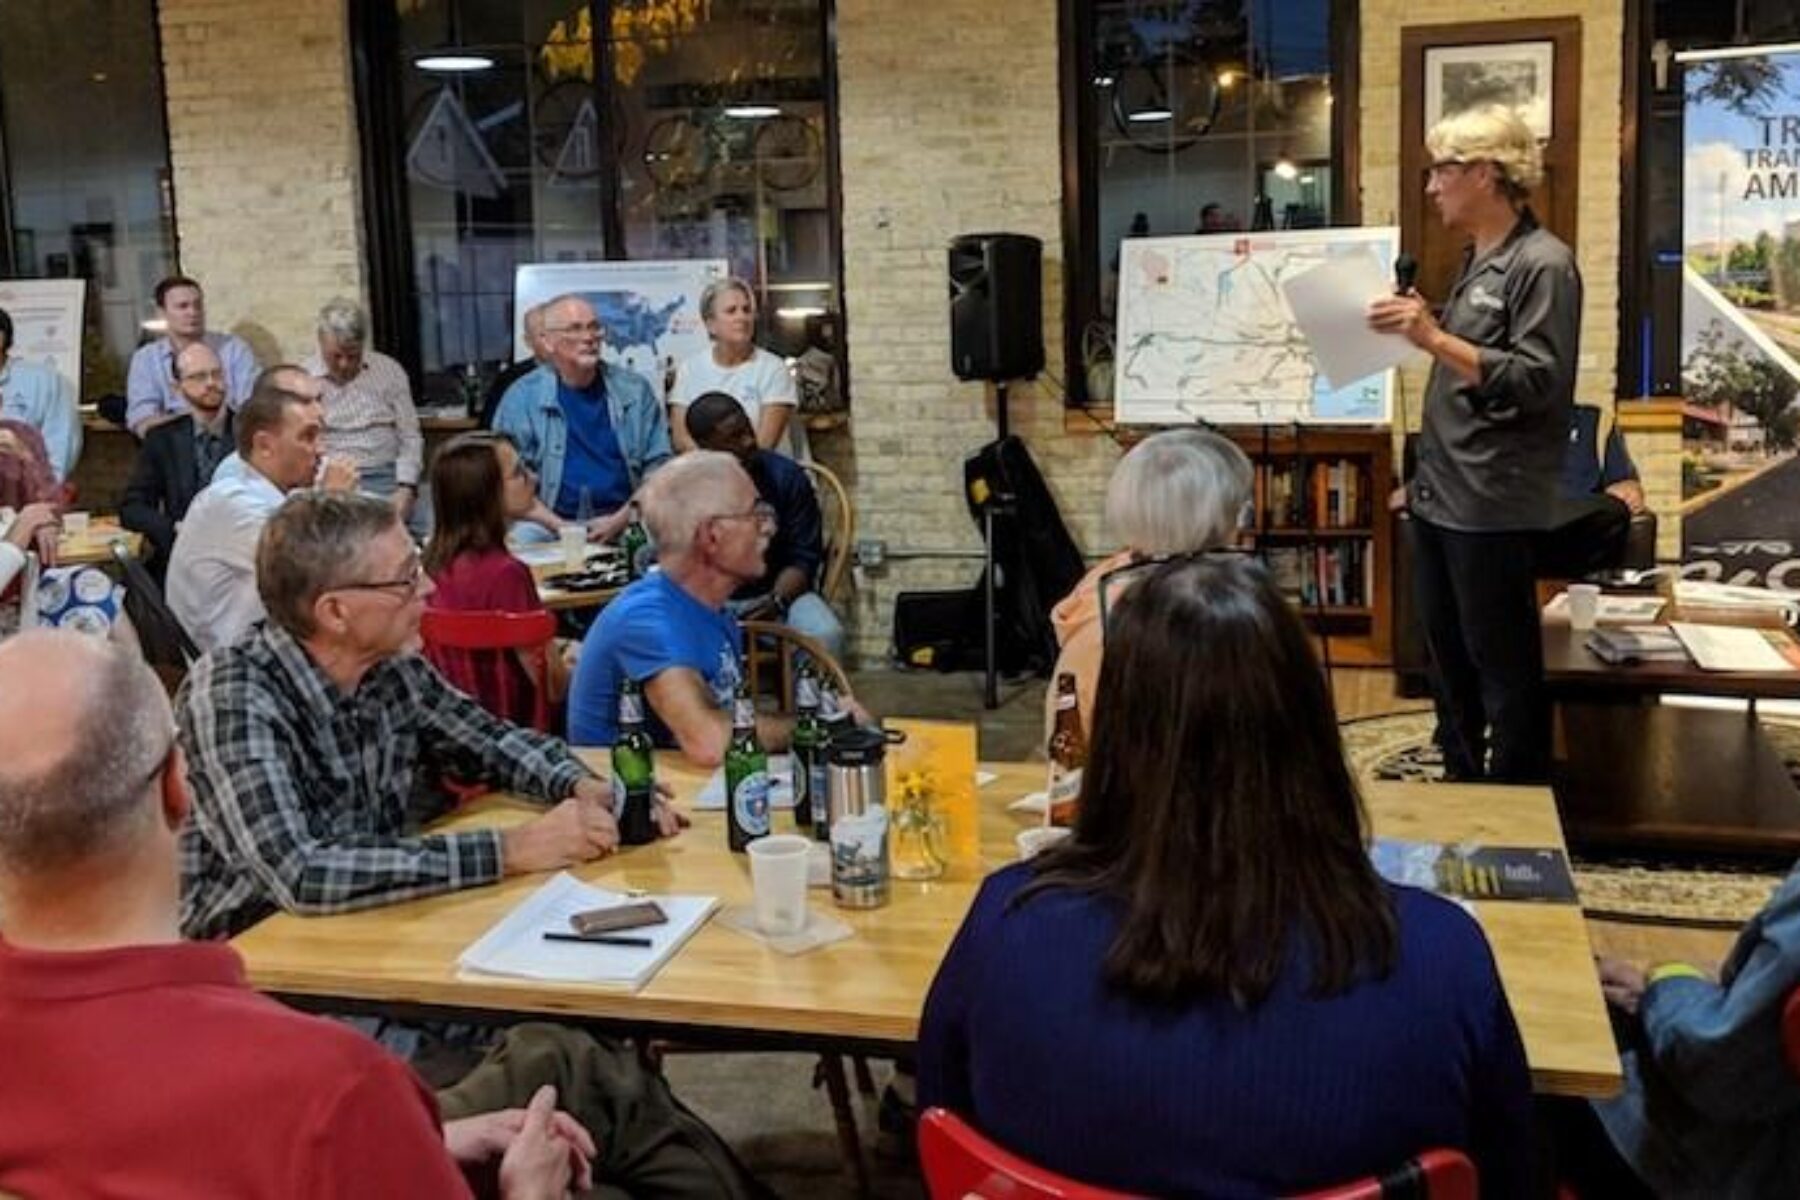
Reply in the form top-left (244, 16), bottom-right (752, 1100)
top-left (513, 259), bottom-right (727, 398)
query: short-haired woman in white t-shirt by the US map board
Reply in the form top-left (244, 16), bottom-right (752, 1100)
top-left (670, 277), bottom-right (799, 450)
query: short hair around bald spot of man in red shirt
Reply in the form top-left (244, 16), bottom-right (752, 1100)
top-left (0, 630), bottom-right (175, 876)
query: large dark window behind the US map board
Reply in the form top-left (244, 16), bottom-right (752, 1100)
top-left (365, 0), bottom-right (839, 402)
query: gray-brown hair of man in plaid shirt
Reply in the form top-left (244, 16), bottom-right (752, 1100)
top-left (256, 489), bottom-right (400, 639)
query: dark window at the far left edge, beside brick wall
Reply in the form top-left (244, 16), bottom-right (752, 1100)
top-left (0, 0), bottom-right (175, 399)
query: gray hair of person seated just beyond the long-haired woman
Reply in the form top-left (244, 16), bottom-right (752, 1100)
top-left (1107, 430), bottom-right (1256, 554)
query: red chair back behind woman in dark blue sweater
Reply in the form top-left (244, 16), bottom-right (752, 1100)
top-left (918, 1108), bottom-right (1476, 1200)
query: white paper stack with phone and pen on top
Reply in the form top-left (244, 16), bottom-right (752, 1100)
top-left (457, 871), bottom-right (718, 991)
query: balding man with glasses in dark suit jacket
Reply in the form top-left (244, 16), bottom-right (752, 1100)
top-left (119, 342), bottom-right (232, 578)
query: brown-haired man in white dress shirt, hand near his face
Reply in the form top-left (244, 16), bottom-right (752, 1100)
top-left (166, 369), bottom-right (356, 649)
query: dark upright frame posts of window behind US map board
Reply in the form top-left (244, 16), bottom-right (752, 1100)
top-left (349, 0), bottom-right (850, 401)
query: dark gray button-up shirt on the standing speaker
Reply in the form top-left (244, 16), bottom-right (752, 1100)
top-left (1408, 209), bottom-right (1582, 531)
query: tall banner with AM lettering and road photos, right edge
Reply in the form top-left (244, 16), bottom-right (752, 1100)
top-left (1681, 49), bottom-right (1800, 592)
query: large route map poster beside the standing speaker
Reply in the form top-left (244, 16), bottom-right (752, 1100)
top-left (1112, 227), bottom-right (1400, 425)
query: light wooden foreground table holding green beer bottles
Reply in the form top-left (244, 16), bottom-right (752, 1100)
top-left (236, 757), bottom-right (1620, 1096)
